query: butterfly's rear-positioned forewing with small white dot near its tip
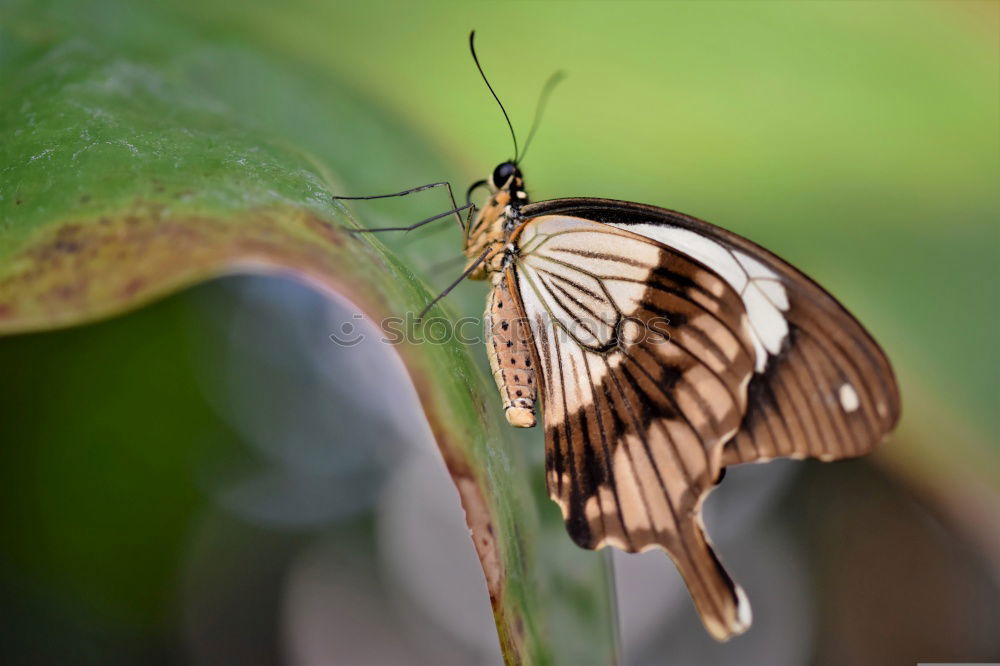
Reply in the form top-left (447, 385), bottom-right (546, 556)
top-left (520, 199), bottom-right (900, 465)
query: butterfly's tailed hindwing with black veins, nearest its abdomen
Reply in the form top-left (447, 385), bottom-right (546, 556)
top-left (513, 215), bottom-right (756, 640)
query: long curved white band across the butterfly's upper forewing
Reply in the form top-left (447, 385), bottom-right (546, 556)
top-left (610, 223), bottom-right (788, 373)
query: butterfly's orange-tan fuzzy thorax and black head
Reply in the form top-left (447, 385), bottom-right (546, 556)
top-left (464, 162), bottom-right (528, 280)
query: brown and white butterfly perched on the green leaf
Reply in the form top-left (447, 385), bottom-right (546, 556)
top-left (342, 33), bottom-right (900, 641)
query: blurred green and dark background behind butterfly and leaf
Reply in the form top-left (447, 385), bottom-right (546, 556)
top-left (0, 0), bottom-right (1000, 664)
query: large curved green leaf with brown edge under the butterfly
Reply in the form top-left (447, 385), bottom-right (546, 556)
top-left (0, 1), bottom-right (613, 663)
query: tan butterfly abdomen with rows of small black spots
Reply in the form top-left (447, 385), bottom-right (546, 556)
top-left (483, 272), bottom-right (538, 428)
